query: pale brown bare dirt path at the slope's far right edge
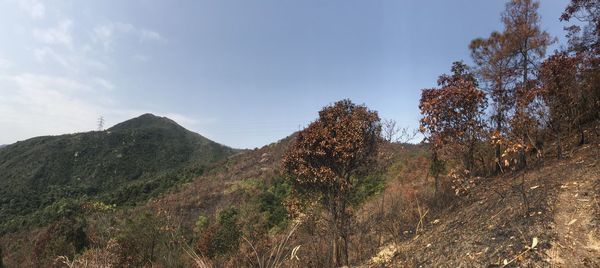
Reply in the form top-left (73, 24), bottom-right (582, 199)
top-left (547, 160), bottom-right (600, 267)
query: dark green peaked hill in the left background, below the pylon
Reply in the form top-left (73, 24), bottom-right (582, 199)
top-left (0, 114), bottom-right (236, 232)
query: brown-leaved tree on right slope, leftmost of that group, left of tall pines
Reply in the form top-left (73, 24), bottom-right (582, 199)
top-left (419, 62), bottom-right (487, 192)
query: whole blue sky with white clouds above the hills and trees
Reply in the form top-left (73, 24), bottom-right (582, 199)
top-left (0, 0), bottom-right (568, 148)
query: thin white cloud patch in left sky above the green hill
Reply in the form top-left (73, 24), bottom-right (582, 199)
top-left (0, 0), bottom-right (188, 144)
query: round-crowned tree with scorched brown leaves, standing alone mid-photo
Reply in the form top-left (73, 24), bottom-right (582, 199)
top-left (283, 99), bottom-right (381, 267)
